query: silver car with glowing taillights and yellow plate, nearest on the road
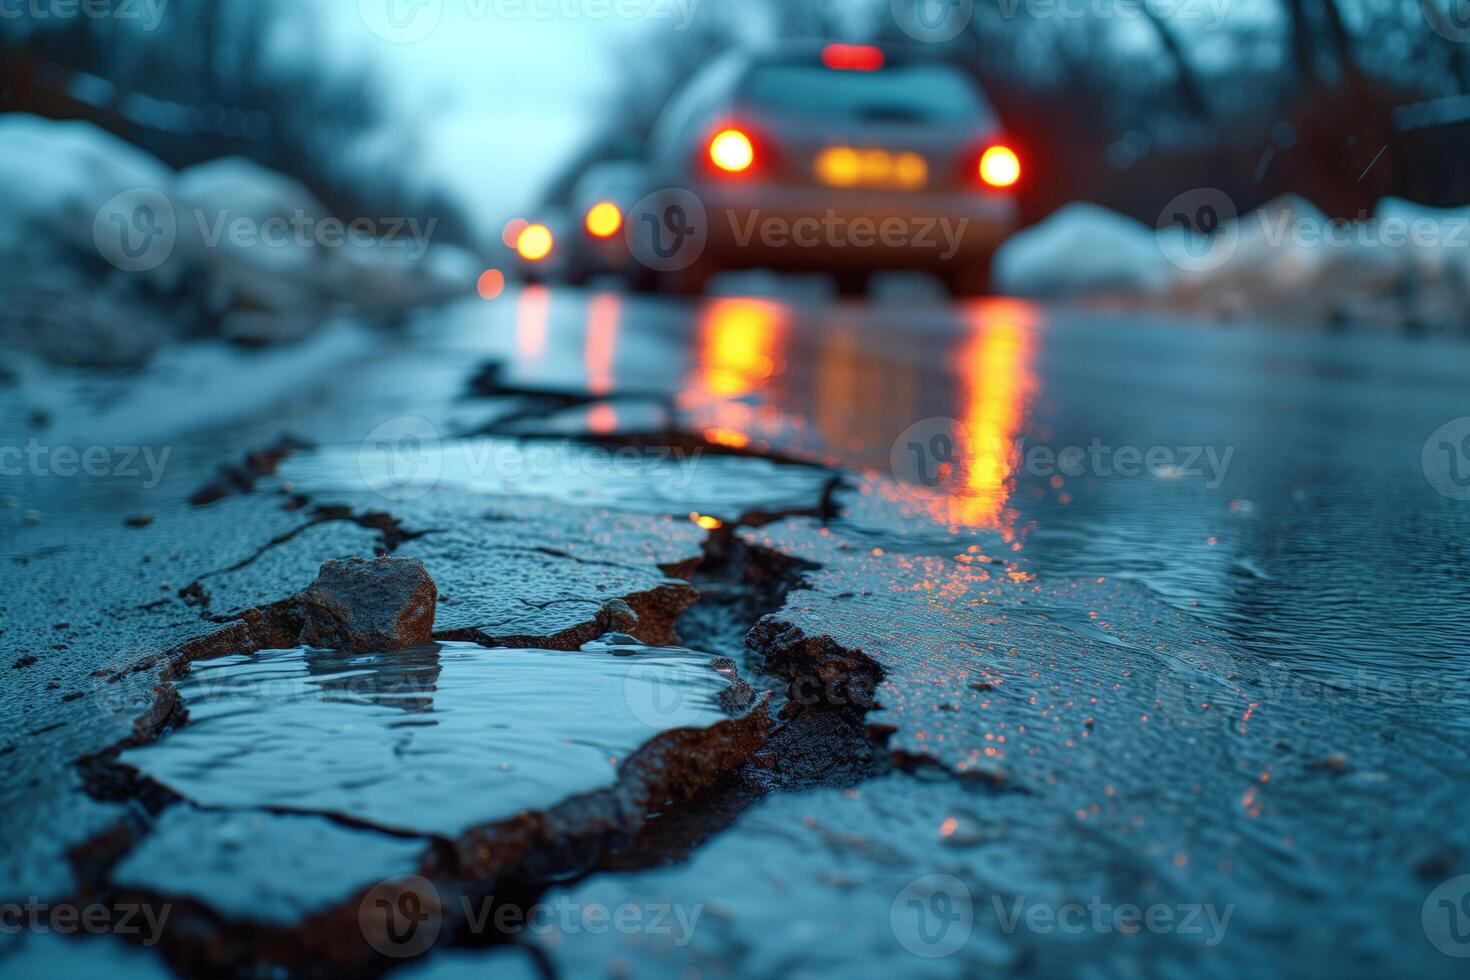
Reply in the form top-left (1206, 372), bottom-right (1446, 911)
top-left (626, 44), bottom-right (1023, 295)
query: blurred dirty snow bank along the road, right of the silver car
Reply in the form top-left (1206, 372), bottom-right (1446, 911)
top-left (995, 192), bottom-right (1470, 331)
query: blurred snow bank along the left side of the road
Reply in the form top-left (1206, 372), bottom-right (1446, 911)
top-left (0, 115), bottom-right (476, 366)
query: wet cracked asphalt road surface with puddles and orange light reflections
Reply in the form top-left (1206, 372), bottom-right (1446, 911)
top-left (0, 288), bottom-right (1470, 977)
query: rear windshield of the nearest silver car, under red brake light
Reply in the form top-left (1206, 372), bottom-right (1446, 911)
top-left (745, 63), bottom-right (980, 122)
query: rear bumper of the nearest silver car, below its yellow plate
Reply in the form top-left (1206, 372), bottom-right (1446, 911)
top-left (691, 184), bottom-right (1019, 270)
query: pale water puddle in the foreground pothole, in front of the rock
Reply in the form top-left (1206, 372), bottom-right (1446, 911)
top-left (122, 644), bottom-right (729, 837)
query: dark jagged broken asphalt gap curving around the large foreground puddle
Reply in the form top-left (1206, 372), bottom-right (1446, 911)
top-left (57, 502), bottom-right (888, 976)
